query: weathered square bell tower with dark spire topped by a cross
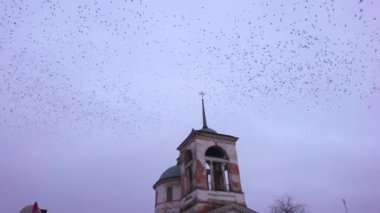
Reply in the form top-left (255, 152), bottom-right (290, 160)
top-left (177, 92), bottom-right (250, 213)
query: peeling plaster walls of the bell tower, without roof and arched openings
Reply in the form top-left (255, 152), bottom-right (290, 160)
top-left (180, 132), bottom-right (246, 213)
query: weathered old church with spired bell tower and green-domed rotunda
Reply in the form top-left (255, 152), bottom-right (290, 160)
top-left (153, 96), bottom-right (256, 213)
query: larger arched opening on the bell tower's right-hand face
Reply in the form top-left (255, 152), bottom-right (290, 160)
top-left (205, 146), bottom-right (230, 191)
